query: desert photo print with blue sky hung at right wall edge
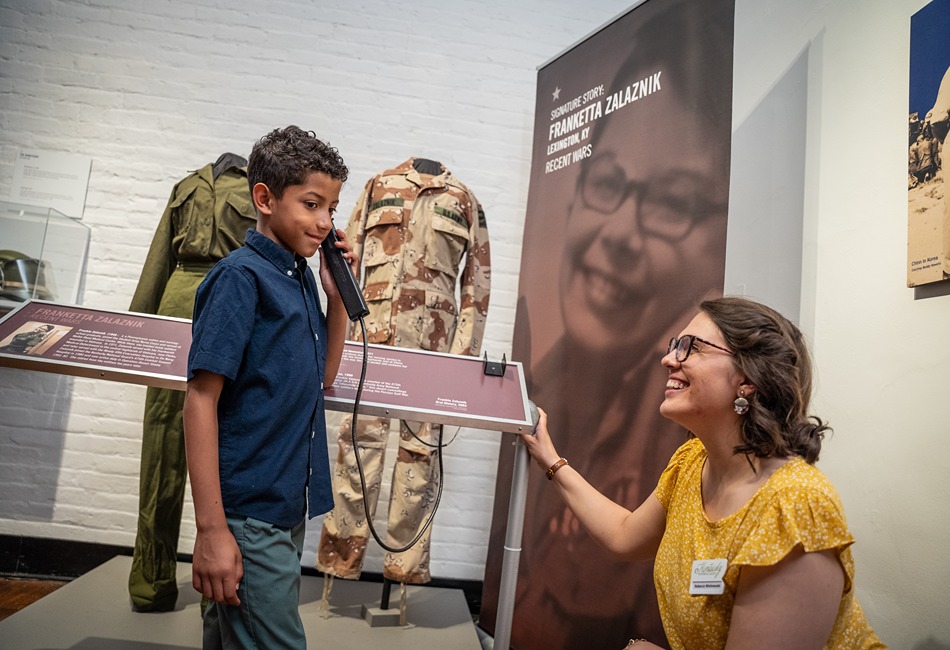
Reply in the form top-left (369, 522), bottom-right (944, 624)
top-left (907, 0), bottom-right (950, 287)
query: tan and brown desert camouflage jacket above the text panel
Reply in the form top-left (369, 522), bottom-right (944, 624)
top-left (346, 158), bottom-right (491, 355)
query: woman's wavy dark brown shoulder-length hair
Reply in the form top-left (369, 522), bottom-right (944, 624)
top-left (699, 296), bottom-right (831, 463)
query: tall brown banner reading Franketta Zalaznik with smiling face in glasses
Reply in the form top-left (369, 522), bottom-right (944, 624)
top-left (479, 0), bottom-right (734, 650)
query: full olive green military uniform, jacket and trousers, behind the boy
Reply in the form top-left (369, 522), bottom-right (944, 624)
top-left (129, 154), bottom-right (257, 611)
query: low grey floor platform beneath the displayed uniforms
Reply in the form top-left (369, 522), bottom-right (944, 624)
top-left (0, 556), bottom-right (481, 650)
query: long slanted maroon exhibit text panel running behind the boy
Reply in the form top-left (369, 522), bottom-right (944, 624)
top-left (0, 301), bottom-right (532, 433)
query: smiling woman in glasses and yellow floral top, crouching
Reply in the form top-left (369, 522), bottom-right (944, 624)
top-left (523, 297), bottom-right (884, 650)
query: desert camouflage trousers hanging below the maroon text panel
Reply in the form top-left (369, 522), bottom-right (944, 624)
top-left (316, 415), bottom-right (441, 584)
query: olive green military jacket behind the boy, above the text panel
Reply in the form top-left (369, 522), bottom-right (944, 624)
top-left (129, 163), bottom-right (257, 314)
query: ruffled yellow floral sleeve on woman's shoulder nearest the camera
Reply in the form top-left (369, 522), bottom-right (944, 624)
top-left (732, 459), bottom-right (854, 591)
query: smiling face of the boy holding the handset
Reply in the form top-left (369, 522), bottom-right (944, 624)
top-left (253, 172), bottom-right (343, 257)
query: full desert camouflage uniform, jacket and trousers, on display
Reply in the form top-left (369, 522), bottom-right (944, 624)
top-left (317, 158), bottom-right (490, 584)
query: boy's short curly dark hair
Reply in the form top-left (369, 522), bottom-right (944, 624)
top-left (247, 125), bottom-right (349, 198)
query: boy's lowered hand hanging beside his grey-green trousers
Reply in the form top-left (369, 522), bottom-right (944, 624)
top-left (191, 526), bottom-right (244, 605)
